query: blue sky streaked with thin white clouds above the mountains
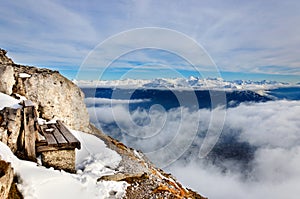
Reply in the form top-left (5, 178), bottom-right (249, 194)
top-left (0, 0), bottom-right (300, 82)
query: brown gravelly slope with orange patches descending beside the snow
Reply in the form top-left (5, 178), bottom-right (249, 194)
top-left (93, 125), bottom-right (205, 199)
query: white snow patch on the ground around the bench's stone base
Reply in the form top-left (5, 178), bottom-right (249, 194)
top-left (0, 131), bottom-right (128, 199)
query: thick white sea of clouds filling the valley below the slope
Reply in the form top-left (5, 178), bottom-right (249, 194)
top-left (85, 100), bottom-right (300, 199)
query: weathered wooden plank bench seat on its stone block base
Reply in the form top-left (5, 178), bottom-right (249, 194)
top-left (36, 120), bottom-right (81, 172)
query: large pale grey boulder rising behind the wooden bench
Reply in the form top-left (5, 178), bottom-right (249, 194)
top-left (0, 49), bottom-right (89, 131)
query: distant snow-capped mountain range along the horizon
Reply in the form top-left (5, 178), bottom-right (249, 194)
top-left (73, 76), bottom-right (291, 90)
